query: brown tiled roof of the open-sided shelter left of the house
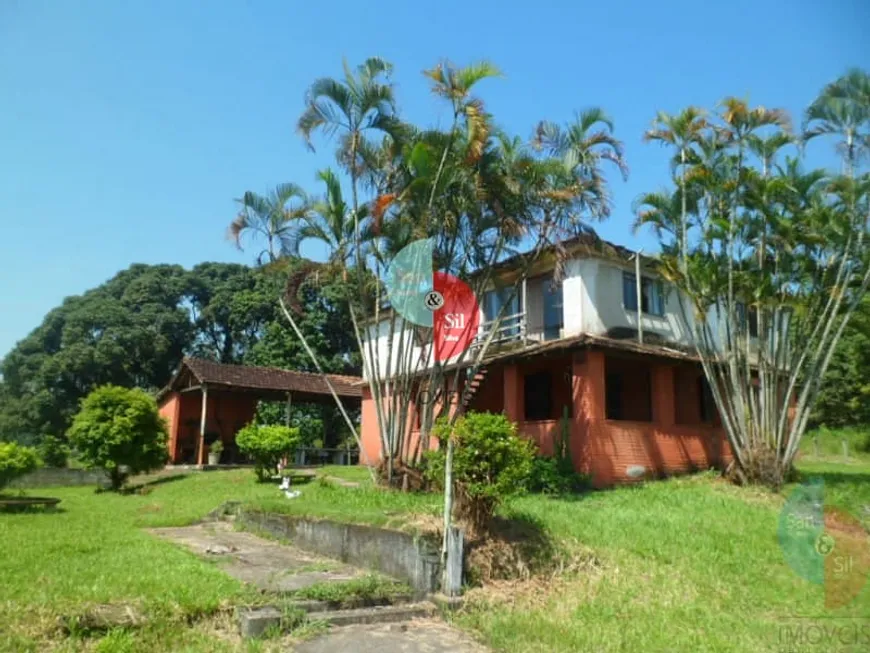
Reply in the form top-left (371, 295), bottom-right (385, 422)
top-left (164, 358), bottom-right (362, 397)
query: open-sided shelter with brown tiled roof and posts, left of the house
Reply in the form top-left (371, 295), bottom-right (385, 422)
top-left (157, 358), bottom-right (362, 465)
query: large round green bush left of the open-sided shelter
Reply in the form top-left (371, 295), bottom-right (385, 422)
top-left (68, 385), bottom-right (167, 490)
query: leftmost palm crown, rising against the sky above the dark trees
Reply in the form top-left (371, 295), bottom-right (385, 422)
top-left (228, 184), bottom-right (308, 265)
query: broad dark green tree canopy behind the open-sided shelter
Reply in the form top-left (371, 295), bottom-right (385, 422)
top-left (0, 260), bottom-right (358, 442)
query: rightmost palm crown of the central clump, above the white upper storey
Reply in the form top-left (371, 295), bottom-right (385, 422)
top-left (533, 107), bottom-right (628, 219)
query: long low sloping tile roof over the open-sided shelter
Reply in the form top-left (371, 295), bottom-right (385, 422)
top-left (157, 358), bottom-right (362, 402)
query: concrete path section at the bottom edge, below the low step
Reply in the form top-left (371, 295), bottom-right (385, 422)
top-left (293, 619), bottom-right (487, 653)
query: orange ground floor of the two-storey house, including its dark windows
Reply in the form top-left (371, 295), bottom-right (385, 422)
top-left (362, 335), bottom-right (731, 487)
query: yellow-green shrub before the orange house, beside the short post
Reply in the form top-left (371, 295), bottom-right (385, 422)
top-left (426, 412), bottom-right (535, 527)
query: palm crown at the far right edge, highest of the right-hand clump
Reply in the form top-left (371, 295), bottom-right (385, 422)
top-left (803, 68), bottom-right (870, 176)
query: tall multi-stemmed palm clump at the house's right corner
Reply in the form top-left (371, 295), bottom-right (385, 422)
top-left (637, 69), bottom-right (870, 487)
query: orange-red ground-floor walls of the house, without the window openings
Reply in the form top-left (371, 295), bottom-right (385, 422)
top-left (362, 350), bottom-right (731, 487)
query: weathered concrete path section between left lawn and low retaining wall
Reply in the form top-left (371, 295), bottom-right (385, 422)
top-left (150, 522), bottom-right (362, 592)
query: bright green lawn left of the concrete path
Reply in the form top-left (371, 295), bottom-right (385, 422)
top-left (0, 470), bottom-right (276, 652)
